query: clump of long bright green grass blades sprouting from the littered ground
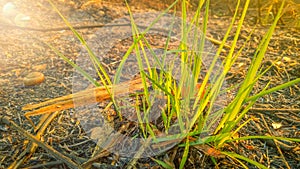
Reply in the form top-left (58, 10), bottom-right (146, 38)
top-left (49, 0), bottom-right (300, 168)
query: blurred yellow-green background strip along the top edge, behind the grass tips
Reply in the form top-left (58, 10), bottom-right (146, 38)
top-left (100, 0), bottom-right (300, 27)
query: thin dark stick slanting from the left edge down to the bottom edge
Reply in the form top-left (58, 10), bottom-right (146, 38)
top-left (0, 116), bottom-right (82, 169)
